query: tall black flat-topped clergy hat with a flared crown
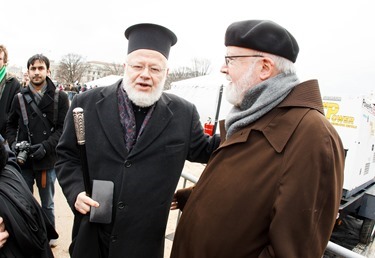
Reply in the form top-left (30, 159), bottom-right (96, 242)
top-left (125, 23), bottom-right (177, 59)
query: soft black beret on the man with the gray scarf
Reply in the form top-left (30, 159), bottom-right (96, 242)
top-left (225, 20), bottom-right (299, 63)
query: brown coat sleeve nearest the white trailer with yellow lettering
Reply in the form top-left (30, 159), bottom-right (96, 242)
top-left (259, 112), bottom-right (345, 258)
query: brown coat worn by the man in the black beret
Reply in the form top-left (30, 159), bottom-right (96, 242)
top-left (171, 80), bottom-right (344, 258)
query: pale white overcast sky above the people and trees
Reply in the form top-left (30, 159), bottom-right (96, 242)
top-left (0, 0), bottom-right (375, 94)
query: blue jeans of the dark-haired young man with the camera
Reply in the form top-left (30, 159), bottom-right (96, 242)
top-left (22, 168), bottom-right (56, 227)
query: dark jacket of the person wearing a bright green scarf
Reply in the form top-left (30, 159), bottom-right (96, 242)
top-left (0, 75), bottom-right (21, 137)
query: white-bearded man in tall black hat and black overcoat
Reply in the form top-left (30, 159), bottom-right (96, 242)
top-left (56, 24), bottom-right (220, 258)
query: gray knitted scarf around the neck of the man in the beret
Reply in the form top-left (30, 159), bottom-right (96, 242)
top-left (225, 73), bottom-right (299, 139)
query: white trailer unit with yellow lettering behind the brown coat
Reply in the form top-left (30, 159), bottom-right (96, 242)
top-left (322, 95), bottom-right (375, 245)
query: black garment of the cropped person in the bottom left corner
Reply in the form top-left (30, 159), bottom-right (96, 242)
top-left (0, 140), bottom-right (58, 258)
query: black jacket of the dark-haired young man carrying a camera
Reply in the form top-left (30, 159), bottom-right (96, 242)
top-left (7, 77), bottom-right (69, 170)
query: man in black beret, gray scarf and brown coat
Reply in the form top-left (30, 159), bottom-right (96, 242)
top-left (171, 20), bottom-right (344, 258)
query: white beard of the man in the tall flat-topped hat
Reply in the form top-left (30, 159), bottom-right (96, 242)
top-left (124, 77), bottom-right (166, 107)
